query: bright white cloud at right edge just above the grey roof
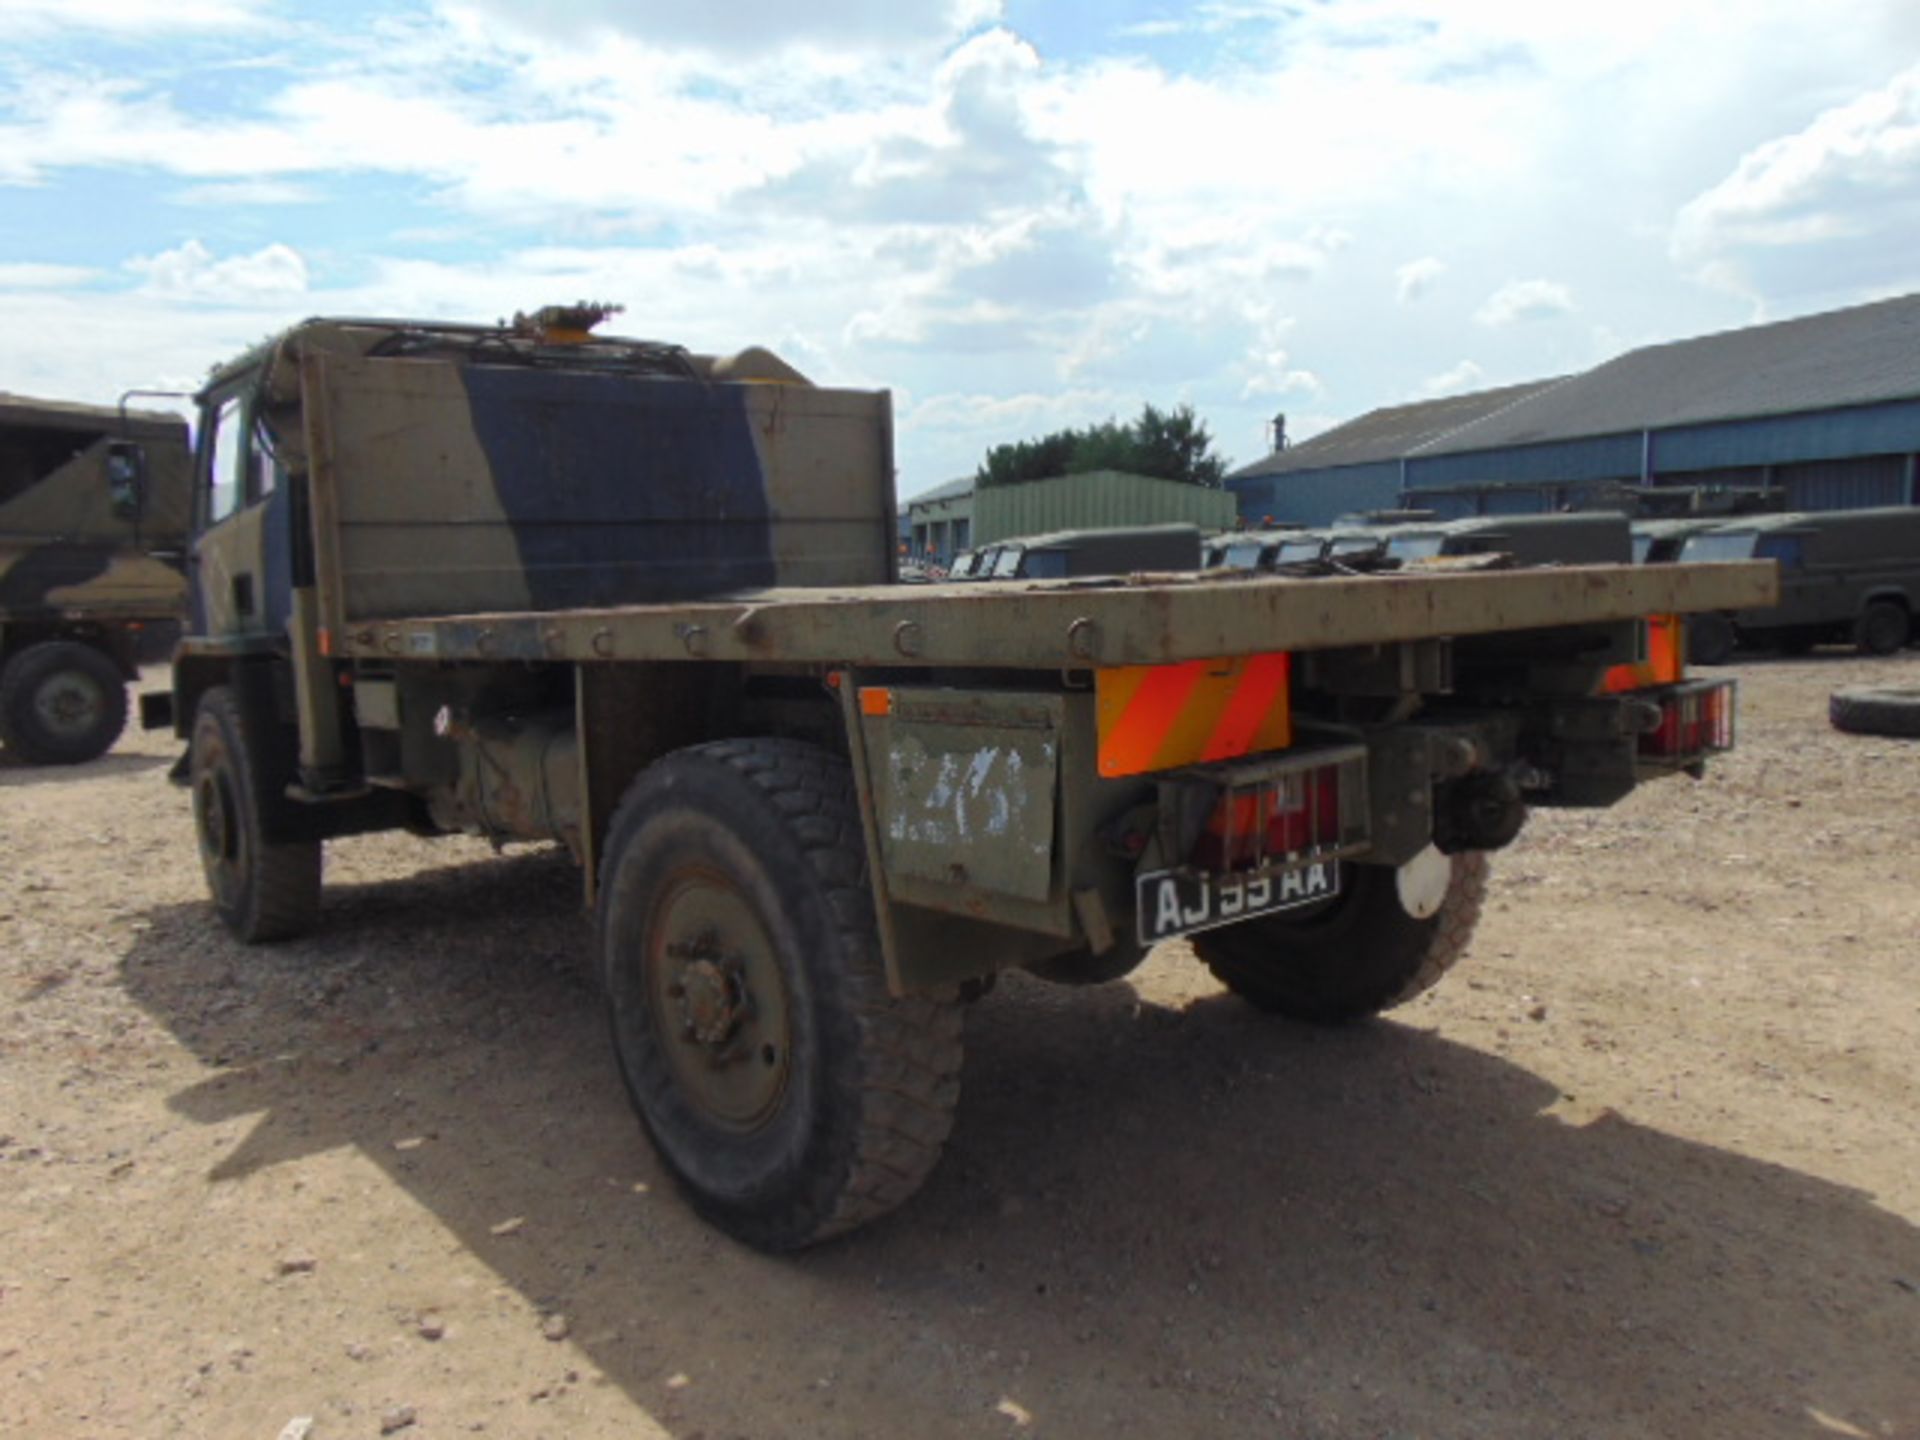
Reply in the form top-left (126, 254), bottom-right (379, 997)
top-left (1672, 65), bottom-right (1920, 303)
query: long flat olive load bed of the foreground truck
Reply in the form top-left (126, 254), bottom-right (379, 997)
top-left (330, 563), bottom-right (1776, 668)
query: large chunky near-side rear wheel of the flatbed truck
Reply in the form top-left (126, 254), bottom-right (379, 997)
top-left (599, 739), bottom-right (962, 1250)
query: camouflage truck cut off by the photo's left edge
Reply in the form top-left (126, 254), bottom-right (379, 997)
top-left (0, 396), bottom-right (190, 764)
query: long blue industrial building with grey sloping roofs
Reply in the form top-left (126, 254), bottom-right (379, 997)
top-left (1227, 296), bottom-right (1920, 526)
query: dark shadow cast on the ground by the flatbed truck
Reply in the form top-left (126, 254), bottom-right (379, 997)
top-left (123, 856), bottom-right (1920, 1440)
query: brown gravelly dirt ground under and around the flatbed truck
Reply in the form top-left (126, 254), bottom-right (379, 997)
top-left (0, 653), bottom-right (1920, 1440)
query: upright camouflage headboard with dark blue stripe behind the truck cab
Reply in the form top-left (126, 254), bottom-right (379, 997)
top-left (243, 321), bottom-right (895, 626)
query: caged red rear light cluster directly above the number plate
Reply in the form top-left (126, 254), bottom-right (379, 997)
top-left (1192, 756), bottom-right (1367, 874)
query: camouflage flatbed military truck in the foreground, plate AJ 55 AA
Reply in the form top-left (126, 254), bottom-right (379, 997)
top-left (150, 313), bottom-right (1772, 1250)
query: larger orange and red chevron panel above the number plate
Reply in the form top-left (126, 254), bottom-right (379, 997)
top-left (1094, 653), bottom-right (1294, 778)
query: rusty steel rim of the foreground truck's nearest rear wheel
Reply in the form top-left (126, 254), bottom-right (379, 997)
top-left (643, 866), bottom-right (793, 1135)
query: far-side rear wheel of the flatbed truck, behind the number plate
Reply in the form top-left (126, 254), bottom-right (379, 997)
top-left (1192, 851), bottom-right (1488, 1023)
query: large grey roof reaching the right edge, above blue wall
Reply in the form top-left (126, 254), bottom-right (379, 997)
top-left (1420, 296), bottom-right (1920, 455)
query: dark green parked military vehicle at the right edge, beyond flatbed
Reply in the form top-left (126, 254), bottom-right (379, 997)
top-left (1680, 505), bottom-right (1920, 664)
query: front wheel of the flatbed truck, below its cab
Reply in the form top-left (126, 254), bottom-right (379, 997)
top-left (186, 685), bottom-right (321, 945)
